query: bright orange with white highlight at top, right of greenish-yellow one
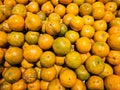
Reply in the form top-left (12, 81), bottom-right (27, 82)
top-left (26, 1), bottom-right (40, 13)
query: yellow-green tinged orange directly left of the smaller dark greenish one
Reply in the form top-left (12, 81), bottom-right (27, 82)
top-left (7, 31), bottom-right (24, 46)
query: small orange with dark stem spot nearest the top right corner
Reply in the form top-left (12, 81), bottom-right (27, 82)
top-left (105, 2), bottom-right (117, 13)
